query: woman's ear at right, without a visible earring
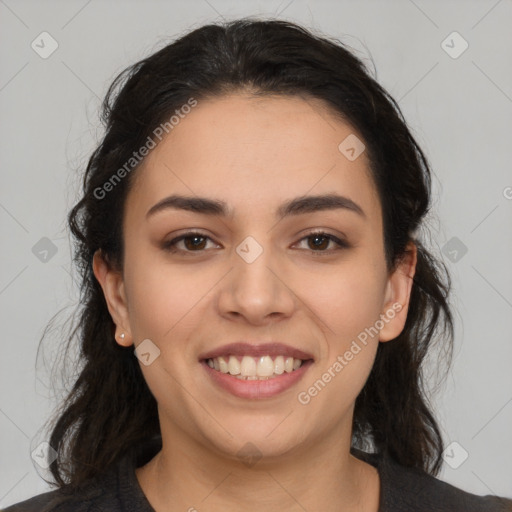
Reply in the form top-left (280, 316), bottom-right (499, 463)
top-left (379, 242), bottom-right (418, 341)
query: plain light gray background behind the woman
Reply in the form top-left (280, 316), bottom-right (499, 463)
top-left (0, 0), bottom-right (512, 507)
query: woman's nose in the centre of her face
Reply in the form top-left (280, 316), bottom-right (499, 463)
top-left (217, 239), bottom-right (297, 325)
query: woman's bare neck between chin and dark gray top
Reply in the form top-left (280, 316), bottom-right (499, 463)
top-left (136, 422), bottom-right (380, 512)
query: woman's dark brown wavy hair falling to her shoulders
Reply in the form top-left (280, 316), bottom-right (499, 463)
top-left (39, 18), bottom-right (453, 488)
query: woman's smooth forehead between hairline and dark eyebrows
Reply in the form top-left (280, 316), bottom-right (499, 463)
top-left (124, 94), bottom-right (379, 224)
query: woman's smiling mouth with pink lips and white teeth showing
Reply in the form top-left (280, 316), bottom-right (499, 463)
top-left (199, 343), bottom-right (314, 399)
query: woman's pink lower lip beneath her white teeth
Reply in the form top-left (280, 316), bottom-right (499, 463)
top-left (201, 359), bottom-right (313, 399)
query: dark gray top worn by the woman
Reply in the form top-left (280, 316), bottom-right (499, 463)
top-left (3, 437), bottom-right (512, 512)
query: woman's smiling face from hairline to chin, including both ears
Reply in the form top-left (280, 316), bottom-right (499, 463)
top-left (94, 94), bottom-right (415, 464)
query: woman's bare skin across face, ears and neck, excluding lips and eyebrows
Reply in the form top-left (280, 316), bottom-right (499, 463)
top-left (93, 92), bottom-right (416, 512)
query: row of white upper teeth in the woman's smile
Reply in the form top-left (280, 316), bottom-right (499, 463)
top-left (207, 355), bottom-right (302, 378)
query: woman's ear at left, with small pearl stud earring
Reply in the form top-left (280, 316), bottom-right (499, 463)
top-left (92, 249), bottom-right (133, 347)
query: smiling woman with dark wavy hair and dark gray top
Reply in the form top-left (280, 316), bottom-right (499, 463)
top-left (7, 19), bottom-right (512, 512)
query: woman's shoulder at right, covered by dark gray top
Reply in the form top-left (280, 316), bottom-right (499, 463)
top-left (356, 451), bottom-right (512, 512)
